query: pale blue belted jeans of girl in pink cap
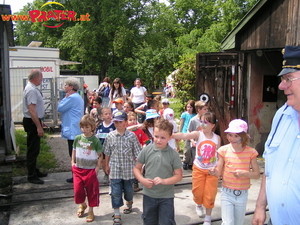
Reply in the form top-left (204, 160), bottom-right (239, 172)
top-left (221, 187), bottom-right (248, 225)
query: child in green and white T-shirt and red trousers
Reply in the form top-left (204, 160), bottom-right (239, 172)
top-left (71, 115), bottom-right (103, 222)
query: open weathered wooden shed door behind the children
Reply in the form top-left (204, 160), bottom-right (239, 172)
top-left (196, 53), bottom-right (244, 143)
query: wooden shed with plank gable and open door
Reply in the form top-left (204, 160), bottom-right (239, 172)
top-left (196, 0), bottom-right (300, 153)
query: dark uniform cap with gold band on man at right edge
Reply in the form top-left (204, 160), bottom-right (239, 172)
top-left (278, 45), bottom-right (300, 76)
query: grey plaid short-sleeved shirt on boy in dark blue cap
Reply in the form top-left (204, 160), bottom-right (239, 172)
top-left (103, 130), bottom-right (142, 180)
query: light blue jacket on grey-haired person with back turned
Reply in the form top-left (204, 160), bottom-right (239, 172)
top-left (57, 93), bottom-right (84, 140)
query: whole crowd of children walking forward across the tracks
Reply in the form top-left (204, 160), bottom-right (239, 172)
top-left (72, 94), bottom-right (260, 225)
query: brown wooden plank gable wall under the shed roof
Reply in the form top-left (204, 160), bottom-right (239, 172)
top-left (237, 0), bottom-right (300, 50)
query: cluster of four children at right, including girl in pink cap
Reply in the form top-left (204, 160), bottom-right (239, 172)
top-left (177, 101), bottom-right (260, 225)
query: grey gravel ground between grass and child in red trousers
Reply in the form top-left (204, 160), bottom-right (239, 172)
top-left (47, 131), bottom-right (71, 173)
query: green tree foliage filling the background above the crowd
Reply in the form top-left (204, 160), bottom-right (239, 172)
top-left (15, 0), bottom-right (258, 101)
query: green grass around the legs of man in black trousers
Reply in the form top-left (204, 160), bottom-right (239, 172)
top-left (13, 129), bottom-right (58, 176)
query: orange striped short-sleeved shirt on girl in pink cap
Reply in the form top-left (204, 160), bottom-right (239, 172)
top-left (218, 144), bottom-right (258, 190)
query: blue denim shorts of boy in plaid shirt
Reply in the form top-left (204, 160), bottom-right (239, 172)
top-left (110, 179), bottom-right (134, 209)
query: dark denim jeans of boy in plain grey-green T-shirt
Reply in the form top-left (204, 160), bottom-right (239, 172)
top-left (142, 195), bottom-right (176, 225)
